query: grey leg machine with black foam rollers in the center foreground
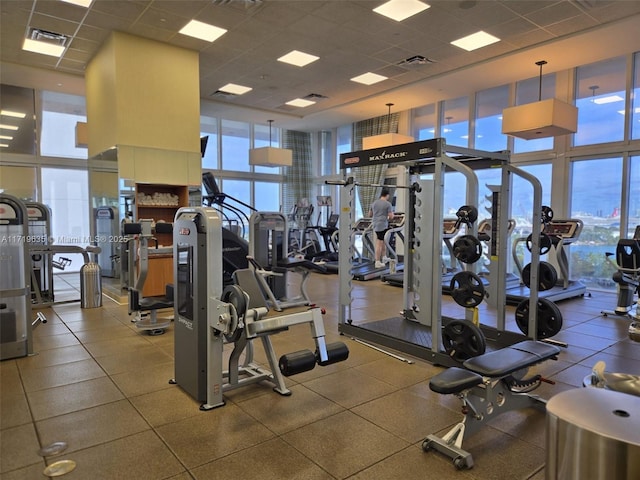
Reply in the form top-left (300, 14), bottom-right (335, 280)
top-left (170, 207), bottom-right (348, 410)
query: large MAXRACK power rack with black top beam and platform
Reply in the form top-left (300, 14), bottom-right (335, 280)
top-left (336, 138), bottom-right (561, 366)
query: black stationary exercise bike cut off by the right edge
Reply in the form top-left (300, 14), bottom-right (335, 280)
top-left (601, 225), bottom-right (640, 342)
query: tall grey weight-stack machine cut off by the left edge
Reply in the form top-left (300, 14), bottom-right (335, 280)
top-left (0, 193), bottom-right (47, 360)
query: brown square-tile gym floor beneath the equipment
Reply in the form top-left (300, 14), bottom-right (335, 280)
top-left (0, 274), bottom-right (640, 480)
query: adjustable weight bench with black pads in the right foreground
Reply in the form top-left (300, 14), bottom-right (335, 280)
top-left (422, 340), bottom-right (560, 469)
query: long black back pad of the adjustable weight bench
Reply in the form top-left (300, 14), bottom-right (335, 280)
top-left (463, 340), bottom-right (560, 377)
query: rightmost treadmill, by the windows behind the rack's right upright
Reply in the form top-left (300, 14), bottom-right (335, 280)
top-left (506, 218), bottom-right (587, 305)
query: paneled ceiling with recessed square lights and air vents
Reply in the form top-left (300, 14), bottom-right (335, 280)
top-left (0, 0), bottom-right (640, 130)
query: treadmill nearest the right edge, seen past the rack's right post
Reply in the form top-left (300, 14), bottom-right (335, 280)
top-left (506, 218), bottom-right (587, 305)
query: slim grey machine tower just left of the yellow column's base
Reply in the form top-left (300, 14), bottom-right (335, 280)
top-left (93, 206), bottom-right (120, 278)
